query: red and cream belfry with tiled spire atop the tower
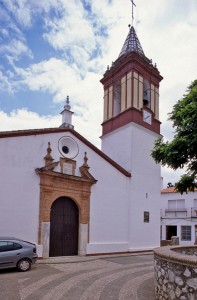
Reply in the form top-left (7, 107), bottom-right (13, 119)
top-left (101, 26), bottom-right (163, 135)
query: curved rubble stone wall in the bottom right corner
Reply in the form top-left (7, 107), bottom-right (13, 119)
top-left (154, 246), bottom-right (197, 300)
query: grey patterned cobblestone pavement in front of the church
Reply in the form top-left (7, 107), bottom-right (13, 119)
top-left (0, 254), bottom-right (154, 300)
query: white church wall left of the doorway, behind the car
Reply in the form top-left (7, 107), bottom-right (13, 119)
top-left (0, 136), bottom-right (42, 250)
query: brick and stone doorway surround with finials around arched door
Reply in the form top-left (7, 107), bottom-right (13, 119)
top-left (35, 143), bottom-right (97, 258)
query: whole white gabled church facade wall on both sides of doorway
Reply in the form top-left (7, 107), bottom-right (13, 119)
top-left (0, 132), bottom-right (131, 255)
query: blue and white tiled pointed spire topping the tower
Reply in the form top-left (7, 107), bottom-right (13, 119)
top-left (119, 26), bottom-right (144, 57)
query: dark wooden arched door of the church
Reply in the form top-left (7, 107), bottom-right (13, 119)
top-left (49, 197), bottom-right (79, 256)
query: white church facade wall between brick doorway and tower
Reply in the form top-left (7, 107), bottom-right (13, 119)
top-left (57, 131), bottom-right (131, 253)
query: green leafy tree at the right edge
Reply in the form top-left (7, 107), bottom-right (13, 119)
top-left (151, 80), bottom-right (197, 194)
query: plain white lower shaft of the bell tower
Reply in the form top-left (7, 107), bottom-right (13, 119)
top-left (102, 123), bottom-right (160, 250)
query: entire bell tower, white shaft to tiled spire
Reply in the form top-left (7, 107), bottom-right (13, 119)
top-left (101, 19), bottom-right (163, 251)
